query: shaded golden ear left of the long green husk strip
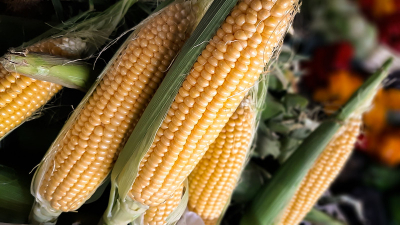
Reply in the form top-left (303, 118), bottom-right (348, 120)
top-left (39, 3), bottom-right (194, 211)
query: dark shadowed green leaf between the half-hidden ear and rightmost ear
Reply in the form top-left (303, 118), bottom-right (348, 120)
top-left (232, 161), bottom-right (270, 203)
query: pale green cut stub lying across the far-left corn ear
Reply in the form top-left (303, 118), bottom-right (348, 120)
top-left (0, 53), bottom-right (92, 91)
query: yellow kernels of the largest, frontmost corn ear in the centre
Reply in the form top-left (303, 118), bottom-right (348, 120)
top-left (129, 0), bottom-right (296, 206)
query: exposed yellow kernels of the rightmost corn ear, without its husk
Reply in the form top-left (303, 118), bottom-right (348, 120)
top-left (279, 116), bottom-right (362, 225)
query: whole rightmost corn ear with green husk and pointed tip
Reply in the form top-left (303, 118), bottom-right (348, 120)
top-left (240, 60), bottom-right (391, 225)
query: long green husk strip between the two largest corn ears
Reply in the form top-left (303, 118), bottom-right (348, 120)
top-left (103, 0), bottom-right (236, 221)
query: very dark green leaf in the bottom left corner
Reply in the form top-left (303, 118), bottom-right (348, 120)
top-left (0, 165), bottom-right (33, 223)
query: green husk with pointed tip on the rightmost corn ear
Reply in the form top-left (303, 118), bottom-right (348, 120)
top-left (240, 59), bottom-right (392, 225)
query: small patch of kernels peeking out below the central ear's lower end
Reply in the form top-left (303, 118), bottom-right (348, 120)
top-left (143, 185), bottom-right (183, 225)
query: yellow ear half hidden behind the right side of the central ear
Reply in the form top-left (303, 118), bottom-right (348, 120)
top-left (188, 100), bottom-right (254, 225)
